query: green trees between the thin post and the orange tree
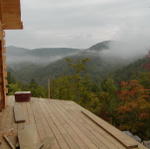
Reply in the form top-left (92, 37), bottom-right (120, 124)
top-left (52, 58), bottom-right (117, 123)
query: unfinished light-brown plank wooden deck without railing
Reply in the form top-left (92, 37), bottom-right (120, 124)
top-left (0, 96), bottom-right (146, 149)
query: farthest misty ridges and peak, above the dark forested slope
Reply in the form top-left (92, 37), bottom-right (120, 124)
top-left (7, 40), bottom-right (150, 65)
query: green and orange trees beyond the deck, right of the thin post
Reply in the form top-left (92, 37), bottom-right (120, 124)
top-left (52, 59), bottom-right (150, 139)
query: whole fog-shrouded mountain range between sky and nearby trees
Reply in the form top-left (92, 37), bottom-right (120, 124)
top-left (7, 41), bottom-right (147, 84)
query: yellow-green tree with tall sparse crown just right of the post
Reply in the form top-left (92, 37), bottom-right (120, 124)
top-left (52, 58), bottom-right (99, 112)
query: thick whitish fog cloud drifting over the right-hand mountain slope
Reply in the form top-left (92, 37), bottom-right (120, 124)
top-left (100, 19), bottom-right (150, 60)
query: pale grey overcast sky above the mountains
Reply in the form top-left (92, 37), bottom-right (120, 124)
top-left (6, 0), bottom-right (150, 48)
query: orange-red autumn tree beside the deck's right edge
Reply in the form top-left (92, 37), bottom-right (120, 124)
top-left (118, 80), bottom-right (150, 139)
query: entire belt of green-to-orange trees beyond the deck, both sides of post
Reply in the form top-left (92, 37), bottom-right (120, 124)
top-left (9, 54), bottom-right (150, 139)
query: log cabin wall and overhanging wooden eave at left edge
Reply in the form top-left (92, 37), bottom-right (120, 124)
top-left (0, 0), bottom-right (23, 111)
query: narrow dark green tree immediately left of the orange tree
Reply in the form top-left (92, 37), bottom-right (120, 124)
top-left (98, 78), bottom-right (118, 125)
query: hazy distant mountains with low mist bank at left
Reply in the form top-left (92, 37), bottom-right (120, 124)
top-left (7, 46), bottom-right (80, 65)
